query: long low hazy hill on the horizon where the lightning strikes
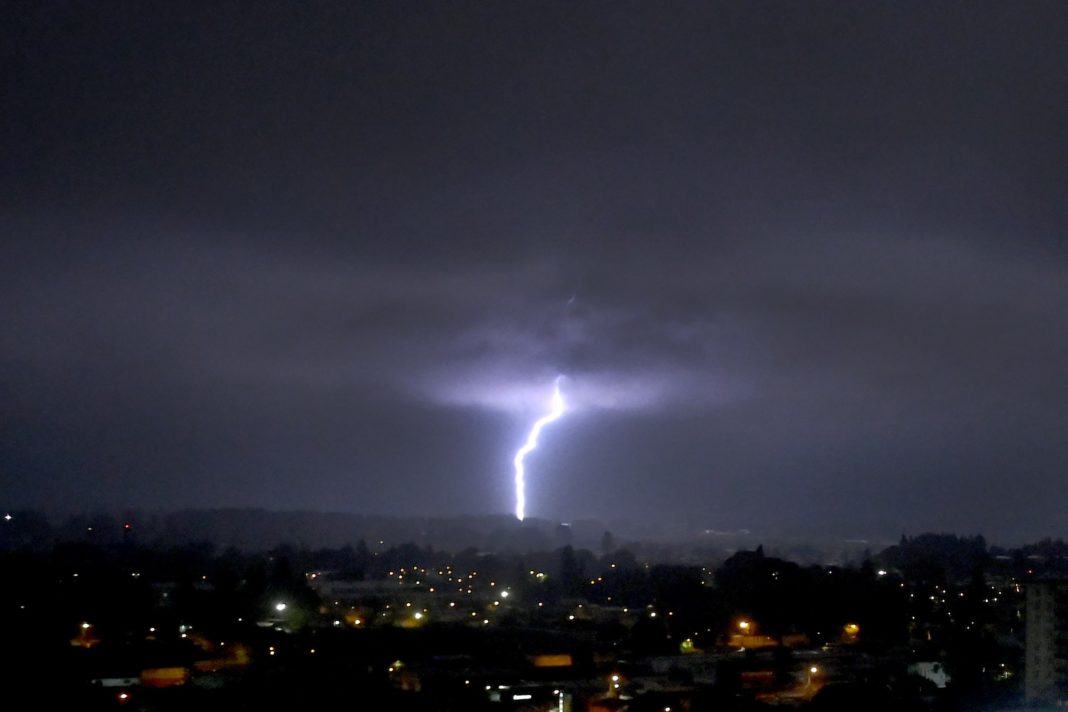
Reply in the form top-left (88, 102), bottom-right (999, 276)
top-left (0, 508), bottom-right (891, 564)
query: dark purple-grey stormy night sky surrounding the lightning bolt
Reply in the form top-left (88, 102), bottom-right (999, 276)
top-left (0, 0), bottom-right (1068, 541)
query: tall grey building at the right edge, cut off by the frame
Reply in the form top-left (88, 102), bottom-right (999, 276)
top-left (1023, 581), bottom-right (1068, 702)
